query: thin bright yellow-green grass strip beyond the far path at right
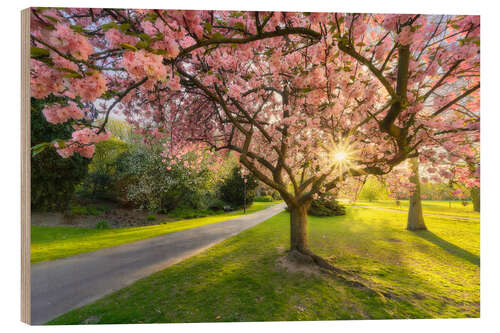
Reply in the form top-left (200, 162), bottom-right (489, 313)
top-left (352, 200), bottom-right (480, 218)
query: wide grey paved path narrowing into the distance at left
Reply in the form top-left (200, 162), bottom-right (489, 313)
top-left (31, 203), bottom-right (285, 325)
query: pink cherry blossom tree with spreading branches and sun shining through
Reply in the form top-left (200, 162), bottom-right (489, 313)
top-left (31, 8), bottom-right (480, 268)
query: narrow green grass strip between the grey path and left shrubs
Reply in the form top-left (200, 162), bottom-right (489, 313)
top-left (31, 202), bottom-right (277, 264)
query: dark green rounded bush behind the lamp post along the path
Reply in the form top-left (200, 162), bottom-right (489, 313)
top-left (219, 167), bottom-right (257, 208)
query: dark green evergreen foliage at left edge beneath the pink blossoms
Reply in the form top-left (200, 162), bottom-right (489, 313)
top-left (31, 96), bottom-right (90, 211)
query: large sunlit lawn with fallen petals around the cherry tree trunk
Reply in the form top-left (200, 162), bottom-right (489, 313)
top-left (48, 207), bottom-right (480, 324)
